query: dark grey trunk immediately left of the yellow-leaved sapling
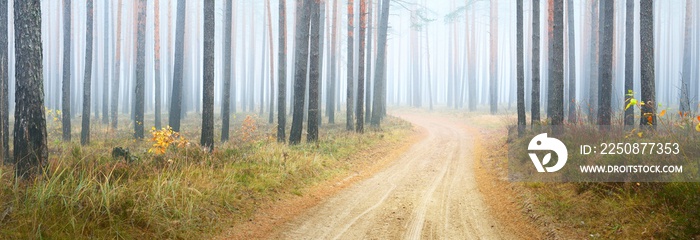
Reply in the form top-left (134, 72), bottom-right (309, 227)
top-left (134, 0), bottom-right (148, 139)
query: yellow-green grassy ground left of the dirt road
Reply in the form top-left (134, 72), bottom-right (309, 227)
top-left (0, 111), bottom-right (411, 239)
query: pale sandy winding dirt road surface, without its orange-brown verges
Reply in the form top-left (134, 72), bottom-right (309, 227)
top-left (273, 114), bottom-right (512, 239)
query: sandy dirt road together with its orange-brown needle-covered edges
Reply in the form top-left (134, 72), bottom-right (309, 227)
top-left (223, 109), bottom-right (541, 239)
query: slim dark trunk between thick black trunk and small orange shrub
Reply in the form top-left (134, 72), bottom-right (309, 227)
top-left (221, 1), bottom-right (233, 142)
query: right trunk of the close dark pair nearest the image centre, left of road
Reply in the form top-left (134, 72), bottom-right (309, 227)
top-left (306, 1), bottom-right (323, 142)
